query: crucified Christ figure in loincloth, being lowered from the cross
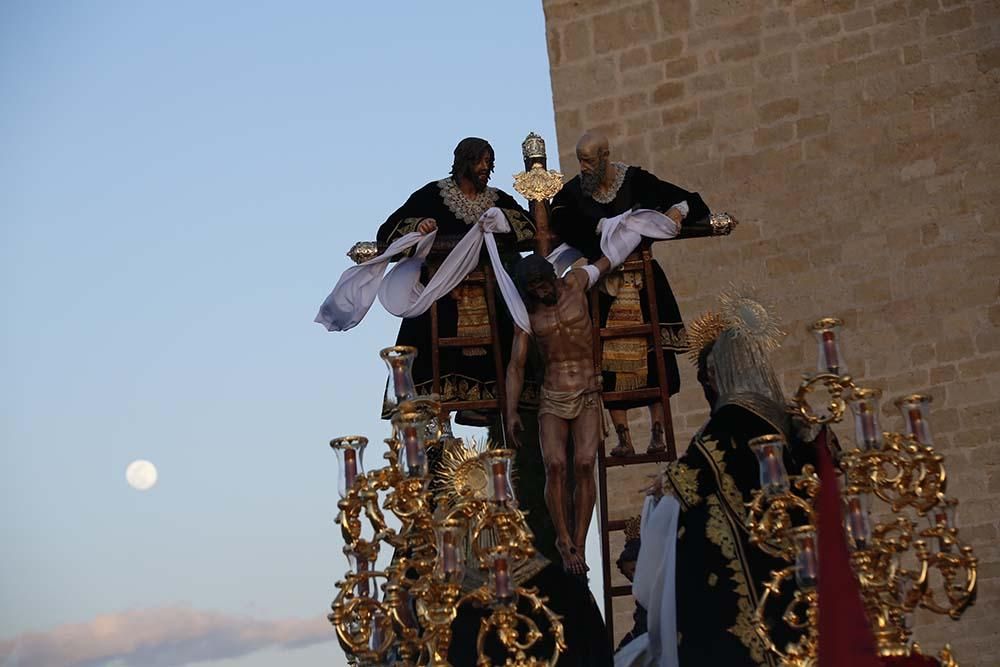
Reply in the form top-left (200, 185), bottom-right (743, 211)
top-left (506, 254), bottom-right (611, 575)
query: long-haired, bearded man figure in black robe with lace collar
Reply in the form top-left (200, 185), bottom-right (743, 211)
top-left (377, 137), bottom-right (534, 426)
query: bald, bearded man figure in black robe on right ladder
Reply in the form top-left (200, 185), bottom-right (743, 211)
top-left (552, 132), bottom-right (710, 456)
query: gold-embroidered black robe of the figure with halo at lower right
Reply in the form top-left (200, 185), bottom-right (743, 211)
top-left (663, 394), bottom-right (815, 667)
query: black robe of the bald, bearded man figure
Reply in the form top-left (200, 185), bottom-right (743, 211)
top-left (552, 167), bottom-right (710, 408)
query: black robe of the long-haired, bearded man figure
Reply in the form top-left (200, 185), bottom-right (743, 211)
top-left (377, 179), bottom-right (535, 425)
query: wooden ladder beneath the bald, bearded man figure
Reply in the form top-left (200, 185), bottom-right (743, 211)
top-left (590, 241), bottom-right (677, 646)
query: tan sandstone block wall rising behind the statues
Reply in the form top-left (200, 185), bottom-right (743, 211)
top-left (543, 0), bottom-right (1000, 666)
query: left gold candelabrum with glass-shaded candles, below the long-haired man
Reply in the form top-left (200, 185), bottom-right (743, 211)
top-left (328, 346), bottom-right (566, 667)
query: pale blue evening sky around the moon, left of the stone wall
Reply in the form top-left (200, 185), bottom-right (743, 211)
top-left (0, 0), bottom-right (557, 667)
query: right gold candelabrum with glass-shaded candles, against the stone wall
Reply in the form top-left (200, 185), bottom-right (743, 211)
top-left (748, 318), bottom-right (977, 667)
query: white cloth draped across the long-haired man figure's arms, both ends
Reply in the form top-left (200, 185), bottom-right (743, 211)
top-left (315, 207), bottom-right (531, 332)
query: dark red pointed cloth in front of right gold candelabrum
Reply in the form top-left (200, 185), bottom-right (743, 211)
top-left (816, 429), bottom-right (883, 667)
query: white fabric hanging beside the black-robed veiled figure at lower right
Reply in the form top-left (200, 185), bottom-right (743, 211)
top-left (615, 495), bottom-right (680, 667)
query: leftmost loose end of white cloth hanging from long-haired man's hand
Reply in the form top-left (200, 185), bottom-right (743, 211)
top-left (313, 231), bottom-right (437, 331)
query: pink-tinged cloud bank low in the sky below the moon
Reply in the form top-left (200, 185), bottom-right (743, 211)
top-left (0, 606), bottom-right (334, 667)
